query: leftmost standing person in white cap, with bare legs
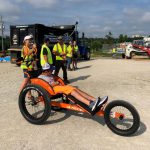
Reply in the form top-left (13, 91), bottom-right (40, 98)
top-left (20, 35), bottom-right (35, 95)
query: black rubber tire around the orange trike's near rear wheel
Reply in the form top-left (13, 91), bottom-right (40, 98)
top-left (19, 84), bottom-right (51, 124)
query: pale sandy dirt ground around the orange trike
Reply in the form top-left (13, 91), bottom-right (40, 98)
top-left (0, 59), bottom-right (150, 150)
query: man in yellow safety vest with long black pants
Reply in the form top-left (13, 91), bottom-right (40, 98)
top-left (53, 36), bottom-right (69, 84)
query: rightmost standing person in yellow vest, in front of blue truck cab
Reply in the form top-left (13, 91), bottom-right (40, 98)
top-left (72, 41), bottom-right (79, 70)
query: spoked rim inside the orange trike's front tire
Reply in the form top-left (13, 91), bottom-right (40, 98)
top-left (109, 106), bottom-right (134, 131)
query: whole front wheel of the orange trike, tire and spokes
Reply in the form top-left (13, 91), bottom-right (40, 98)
top-left (104, 100), bottom-right (140, 136)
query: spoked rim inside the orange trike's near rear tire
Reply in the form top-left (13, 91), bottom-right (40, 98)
top-left (23, 89), bottom-right (46, 120)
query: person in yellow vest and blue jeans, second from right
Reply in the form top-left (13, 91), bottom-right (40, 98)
top-left (67, 41), bottom-right (74, 71)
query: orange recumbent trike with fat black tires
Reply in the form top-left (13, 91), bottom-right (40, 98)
top-left (19, 77), bottom-right (140, 136)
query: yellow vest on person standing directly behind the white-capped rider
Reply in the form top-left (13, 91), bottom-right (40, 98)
top-left (40, 44), bottom-right (53, 66)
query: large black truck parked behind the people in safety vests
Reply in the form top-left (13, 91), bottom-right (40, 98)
top-left (8, 24), bottom-right (90, 63)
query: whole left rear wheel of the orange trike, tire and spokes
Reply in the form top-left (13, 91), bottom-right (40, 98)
top-left (18, 84), bottom-right (51, 124)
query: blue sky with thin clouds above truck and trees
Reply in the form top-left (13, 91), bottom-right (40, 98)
top-left (0, 0), bottom-right (150, 37)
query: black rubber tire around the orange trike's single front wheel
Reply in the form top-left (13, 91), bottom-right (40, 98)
top-left (104, 100), bottom-right (140, 136)
